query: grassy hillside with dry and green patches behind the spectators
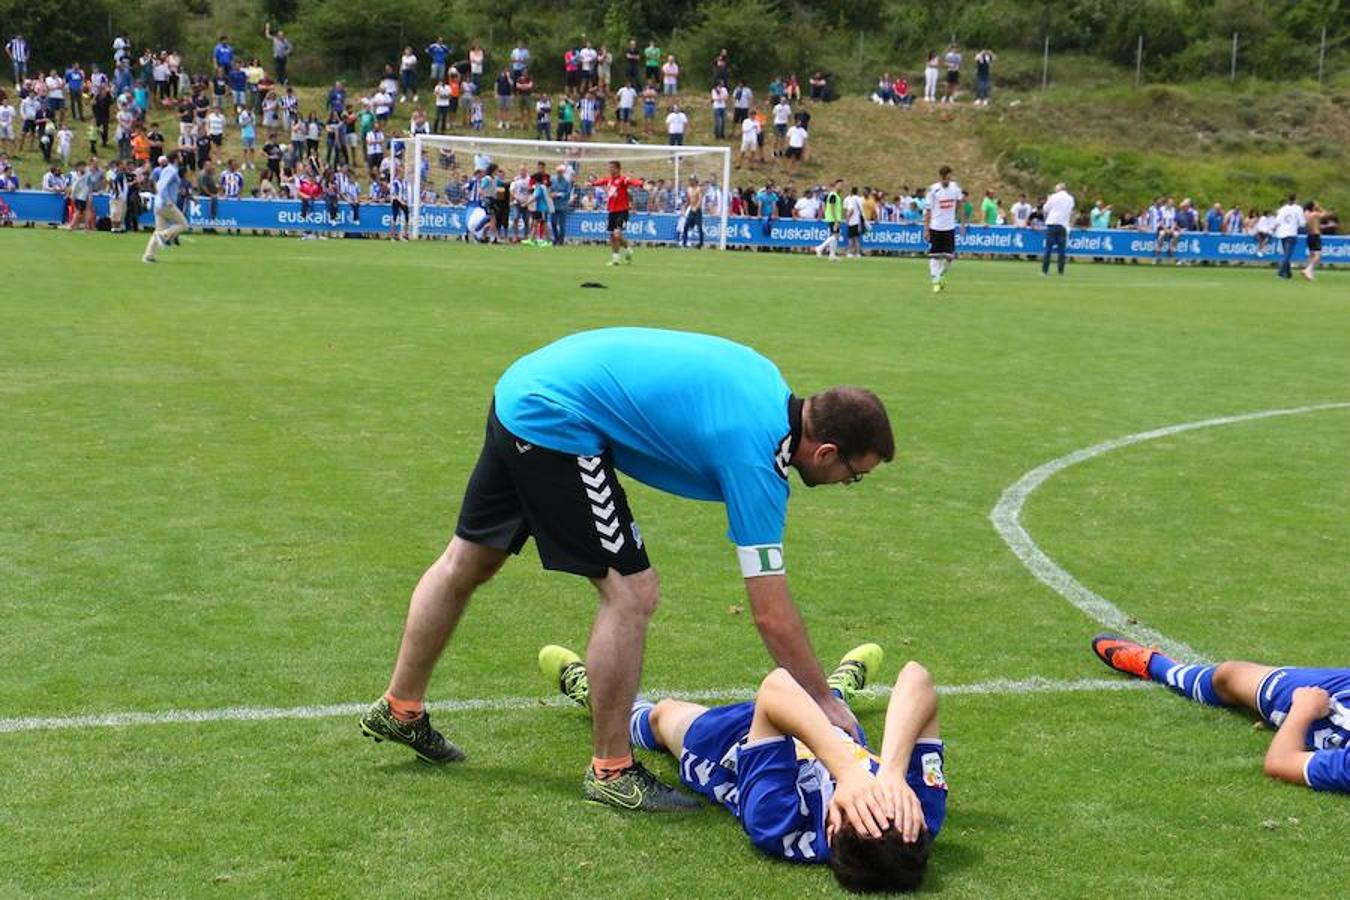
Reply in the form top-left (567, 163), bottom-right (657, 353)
top-left (5, 54), bottom-right (1350, 210)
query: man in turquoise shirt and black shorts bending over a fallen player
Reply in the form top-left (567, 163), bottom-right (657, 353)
top-left (360, 328), bottom-right (895, 810)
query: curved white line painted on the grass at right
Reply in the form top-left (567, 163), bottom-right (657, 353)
top-left (990, 403), bottom-right (1350, 661)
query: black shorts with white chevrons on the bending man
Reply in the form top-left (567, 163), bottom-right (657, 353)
top-left (455, 409), bottom-right (652, 578)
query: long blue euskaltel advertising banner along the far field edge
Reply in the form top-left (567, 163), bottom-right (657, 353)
top-left (0, 190), bottom-right (1350, 264)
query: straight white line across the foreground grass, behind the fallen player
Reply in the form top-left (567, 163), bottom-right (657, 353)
top-left (0, 677), bottom-right (1149, 734)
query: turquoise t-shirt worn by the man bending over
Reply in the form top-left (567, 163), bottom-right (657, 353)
top-left (494, 328), bottom-right (801, 550)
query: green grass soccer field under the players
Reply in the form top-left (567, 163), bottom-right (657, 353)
top-left (0, 231), bottom-right (1350, 899)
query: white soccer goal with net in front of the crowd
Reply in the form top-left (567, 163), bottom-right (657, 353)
top-left (400, 135), bottom-right (732, 250)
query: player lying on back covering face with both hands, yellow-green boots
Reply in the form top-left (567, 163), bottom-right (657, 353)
top-left (539, 644), bottom-right (946, 892)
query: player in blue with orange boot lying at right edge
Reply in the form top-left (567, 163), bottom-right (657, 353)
top-left (1092, 634), bottom-right (1350, 793)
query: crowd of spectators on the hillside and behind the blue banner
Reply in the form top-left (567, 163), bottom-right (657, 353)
top-left (0, 26), bottom-right (1335, 246)
